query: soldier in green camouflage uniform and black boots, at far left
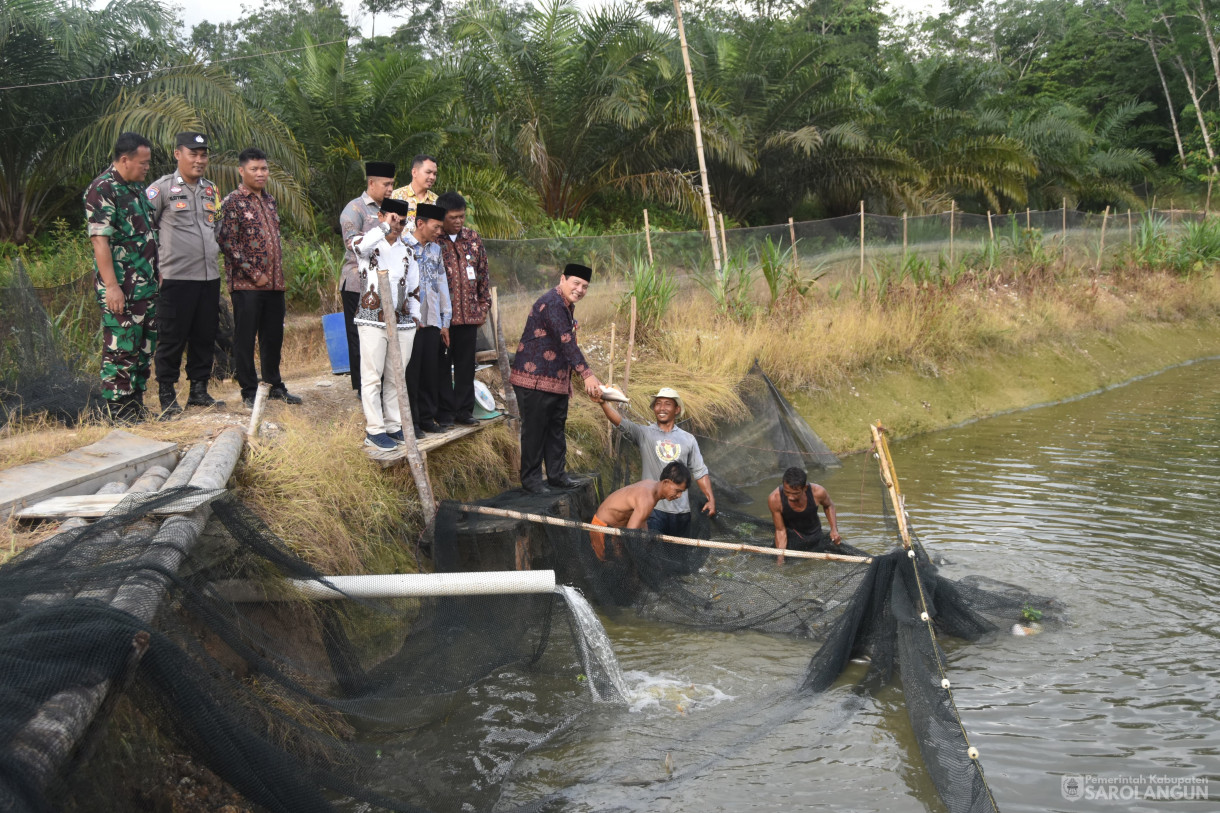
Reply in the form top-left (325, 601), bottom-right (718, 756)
top-left (84, 133), bottom-right (160, 420)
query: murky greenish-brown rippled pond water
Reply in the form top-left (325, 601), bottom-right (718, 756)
top-left (353, 361), bottom-right (1220, 813)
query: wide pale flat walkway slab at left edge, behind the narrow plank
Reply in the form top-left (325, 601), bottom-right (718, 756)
top-left (0, 430), bottom-right (178, 518)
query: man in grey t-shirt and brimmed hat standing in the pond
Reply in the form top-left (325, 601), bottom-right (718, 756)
top-left (592, 387), bottom-right (716, 537)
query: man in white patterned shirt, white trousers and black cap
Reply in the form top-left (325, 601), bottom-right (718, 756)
top-left (351, 198), bottom-right (420, 449)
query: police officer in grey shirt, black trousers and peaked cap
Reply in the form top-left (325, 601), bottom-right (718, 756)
top-left (146, 132), bottom-right (224, 417)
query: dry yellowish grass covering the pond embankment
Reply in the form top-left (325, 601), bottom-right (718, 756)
top-left (0, 260), bottom-right (1220, 574)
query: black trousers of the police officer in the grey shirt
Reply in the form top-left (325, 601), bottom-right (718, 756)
top-left (154, 278), bottom-right (221, 385)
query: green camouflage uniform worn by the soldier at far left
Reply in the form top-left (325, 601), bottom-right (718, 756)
top-left (84, 166), bottom-right (160, 400)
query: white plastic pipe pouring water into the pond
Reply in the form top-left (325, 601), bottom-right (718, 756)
top-left (212, 570), bottom-right (555, 604)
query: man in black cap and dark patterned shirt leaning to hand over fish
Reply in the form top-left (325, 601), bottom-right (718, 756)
top-left (509, 262), bottom-right (601, 494)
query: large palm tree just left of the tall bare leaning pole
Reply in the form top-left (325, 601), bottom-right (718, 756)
top-left (455, 0), bottom-right (698, 220)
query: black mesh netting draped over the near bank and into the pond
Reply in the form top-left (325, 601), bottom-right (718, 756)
top-left (0, 374), bottom-right (1055, 812)
